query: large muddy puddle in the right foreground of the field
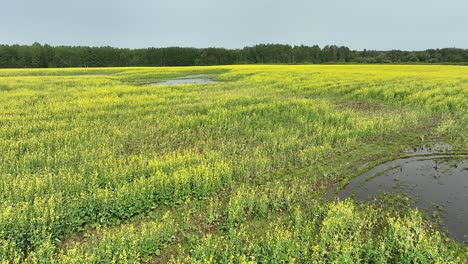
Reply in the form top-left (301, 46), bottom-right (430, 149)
top-left (338, 145), bottom-right (468, 243)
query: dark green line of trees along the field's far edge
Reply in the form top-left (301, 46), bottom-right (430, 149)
top-left (0, 43), bottom-right (468, 68)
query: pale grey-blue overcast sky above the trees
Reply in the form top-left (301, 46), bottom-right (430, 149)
top-left (0, 0), bottom-right (468, 50)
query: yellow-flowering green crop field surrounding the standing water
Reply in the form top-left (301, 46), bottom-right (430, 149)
top-left (0, 65), bottom-right (468, 263)
